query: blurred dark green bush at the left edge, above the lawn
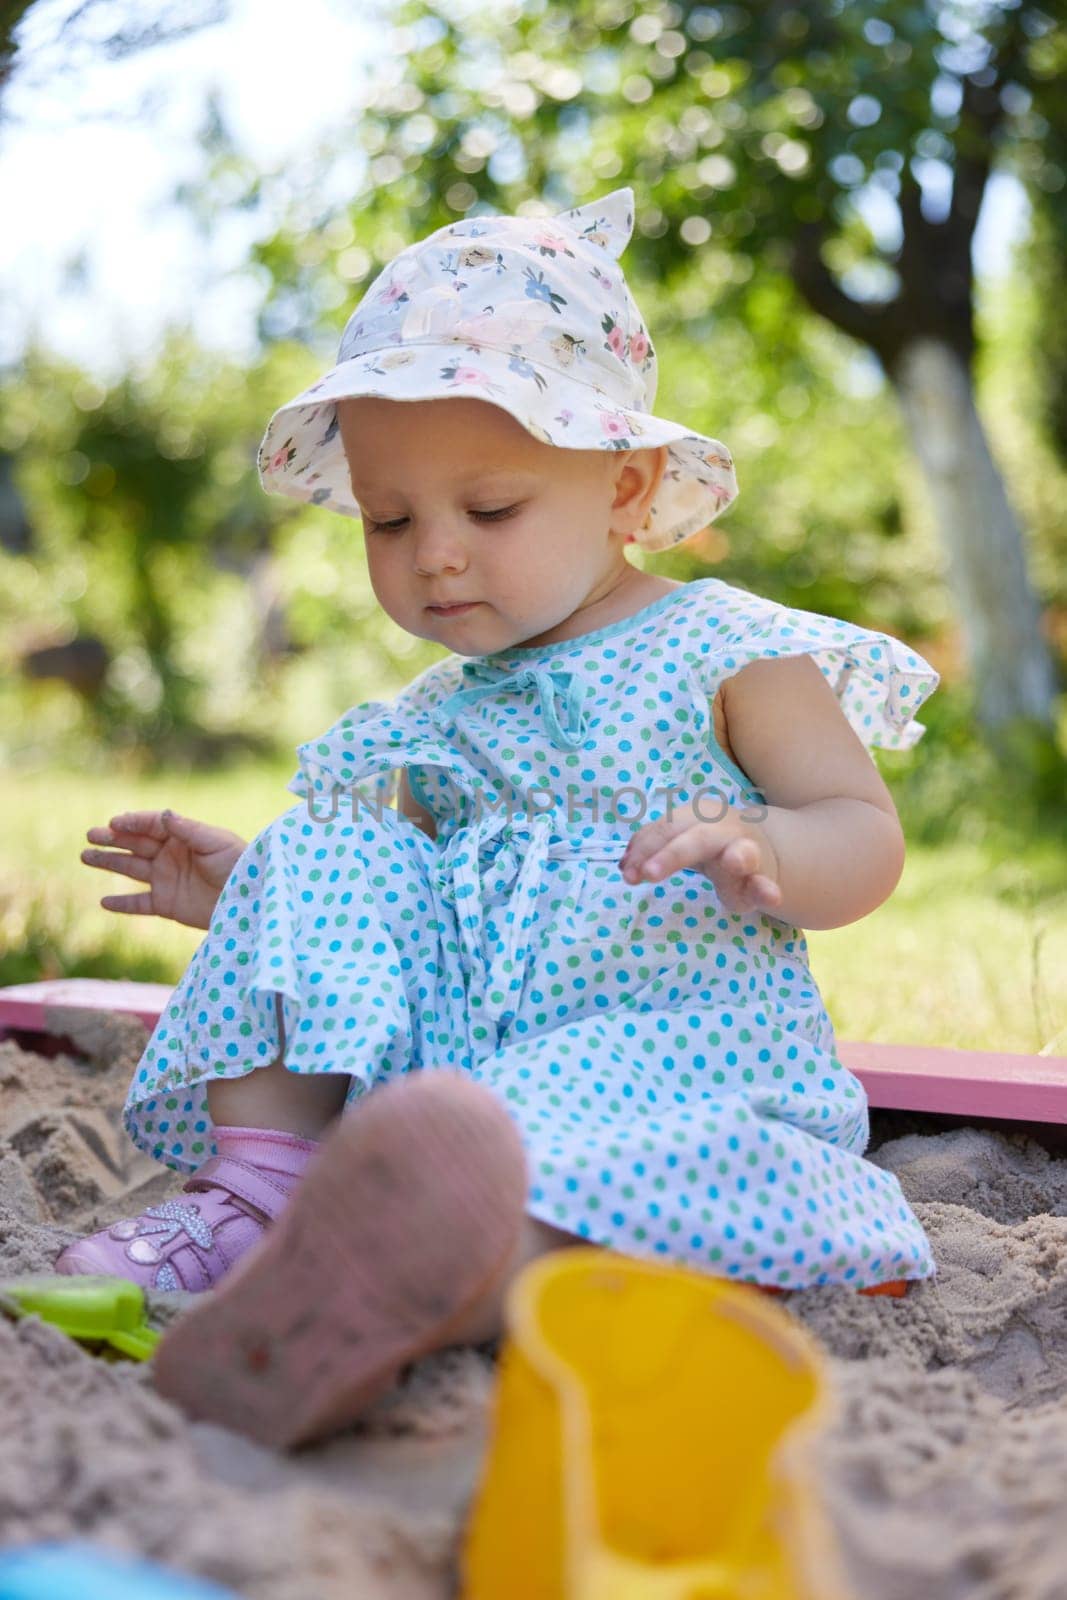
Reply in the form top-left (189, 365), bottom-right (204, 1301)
top-left (2, 334), bottom-right (286, 758)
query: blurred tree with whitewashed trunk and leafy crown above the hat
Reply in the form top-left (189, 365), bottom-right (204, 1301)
top-left (244, 0), bottom-right (1067, 763)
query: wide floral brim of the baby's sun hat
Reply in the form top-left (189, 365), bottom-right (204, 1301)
top-left (259, 341), bottom-right (737, 550)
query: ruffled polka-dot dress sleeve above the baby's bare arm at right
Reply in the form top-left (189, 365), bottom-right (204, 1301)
top-left (702, 584), bottom-right (941, 750)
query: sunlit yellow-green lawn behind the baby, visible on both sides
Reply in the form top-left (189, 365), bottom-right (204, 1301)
top-left (0, 760), bottom-right (1067, 1054)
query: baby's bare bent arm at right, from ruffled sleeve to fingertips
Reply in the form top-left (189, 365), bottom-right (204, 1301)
top-left (624, 656), bottom-right (904, 928)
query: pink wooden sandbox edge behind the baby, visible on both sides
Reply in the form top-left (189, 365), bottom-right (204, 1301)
top-left (0, 978), bottom-right (1067, 1123)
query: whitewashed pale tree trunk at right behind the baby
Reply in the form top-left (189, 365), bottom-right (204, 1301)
top-left (891, 338), bottom-right (1056, 734)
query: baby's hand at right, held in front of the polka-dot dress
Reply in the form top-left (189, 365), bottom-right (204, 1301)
top-left (619, 805), bottom-right (782, 912)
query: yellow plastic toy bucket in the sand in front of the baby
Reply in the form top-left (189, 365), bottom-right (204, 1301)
top-left (461, 1250), bottom-right (853, 1600)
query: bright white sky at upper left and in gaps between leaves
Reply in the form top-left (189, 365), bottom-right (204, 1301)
top-left (0, 0), bottom-right (1030, 378)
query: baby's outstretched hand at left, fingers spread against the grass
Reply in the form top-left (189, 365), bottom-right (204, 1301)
top-left (82, 811), bottom-right (245, 928)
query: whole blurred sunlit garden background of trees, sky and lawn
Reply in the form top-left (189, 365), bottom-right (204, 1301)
top-left (0, 0), bottom-right (1067, 1053)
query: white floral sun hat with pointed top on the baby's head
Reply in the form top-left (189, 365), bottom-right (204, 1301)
top-left (259, 189), bottom-right (737, 550)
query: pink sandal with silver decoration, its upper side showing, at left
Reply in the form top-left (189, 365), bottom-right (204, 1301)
top-left (54, 1128), bottom-right (318, 1293)
